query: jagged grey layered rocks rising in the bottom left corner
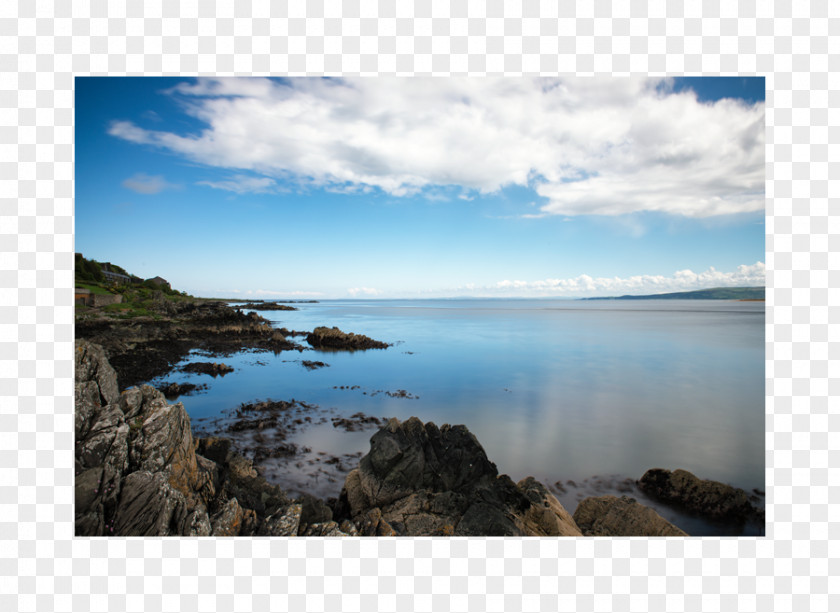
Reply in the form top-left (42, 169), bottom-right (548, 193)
top-left (75, 341), bottom-right (298, 536)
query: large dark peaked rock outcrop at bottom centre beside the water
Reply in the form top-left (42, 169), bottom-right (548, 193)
top-left (334, 417), bottom-right (581, 536)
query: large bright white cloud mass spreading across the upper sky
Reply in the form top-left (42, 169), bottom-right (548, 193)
top-left (109, 78), bottom-right (764, 217)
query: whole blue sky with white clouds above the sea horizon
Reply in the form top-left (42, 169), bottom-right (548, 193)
top-left (75, 77), bottom-right (765, 299)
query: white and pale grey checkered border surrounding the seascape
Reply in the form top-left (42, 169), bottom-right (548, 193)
top-left (0, 0), bottom-right (840, 612)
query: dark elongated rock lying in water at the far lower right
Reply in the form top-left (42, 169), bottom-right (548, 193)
top-left (638, 468), bottom-right (760, 521)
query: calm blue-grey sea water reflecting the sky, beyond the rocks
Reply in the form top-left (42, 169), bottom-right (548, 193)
top-left (149, 300), bottom-right (765, 533)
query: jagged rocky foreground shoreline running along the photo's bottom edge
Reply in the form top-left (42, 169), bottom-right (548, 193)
top-left (75, 341), bottom-right (760, 536)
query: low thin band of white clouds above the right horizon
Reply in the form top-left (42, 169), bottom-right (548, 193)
top-left (459, 262), bottom-right (765, 298)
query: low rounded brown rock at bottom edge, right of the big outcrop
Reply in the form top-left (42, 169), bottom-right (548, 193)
top-left (574, 496), bottom-right (688, 536)
